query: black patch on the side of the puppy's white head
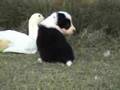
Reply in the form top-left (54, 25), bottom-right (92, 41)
top-left (57, 12), bottom-right (71, 29)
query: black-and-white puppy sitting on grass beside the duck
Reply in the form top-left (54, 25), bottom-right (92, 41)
top-left (37, 11), bottom-right (75, 66)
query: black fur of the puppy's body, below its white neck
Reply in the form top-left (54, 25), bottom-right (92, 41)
top-left (37, 25), bottom-right (74, 63)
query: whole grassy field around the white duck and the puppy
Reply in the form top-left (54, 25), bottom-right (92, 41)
top-left (0, 0), bottom-right (120, 90)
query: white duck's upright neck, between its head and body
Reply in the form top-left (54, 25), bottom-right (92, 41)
top-left (28, 22), bottom-right (38, 40)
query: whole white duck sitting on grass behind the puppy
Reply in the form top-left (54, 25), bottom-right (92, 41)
top-left (0, 13), bottom-right (44, 54)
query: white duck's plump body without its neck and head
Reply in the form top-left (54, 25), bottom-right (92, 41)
top-left (0, 30), bottom-right (37, 54)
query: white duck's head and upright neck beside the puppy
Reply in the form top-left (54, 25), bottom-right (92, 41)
top-left (28, 13), bottom-right (44, 40)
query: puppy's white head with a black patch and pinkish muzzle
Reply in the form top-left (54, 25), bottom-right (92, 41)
top-left (42, 11), bottom-right (76, 35)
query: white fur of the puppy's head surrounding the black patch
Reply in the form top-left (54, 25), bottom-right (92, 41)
top-left (41, 11), bottom-right (76, 35)
